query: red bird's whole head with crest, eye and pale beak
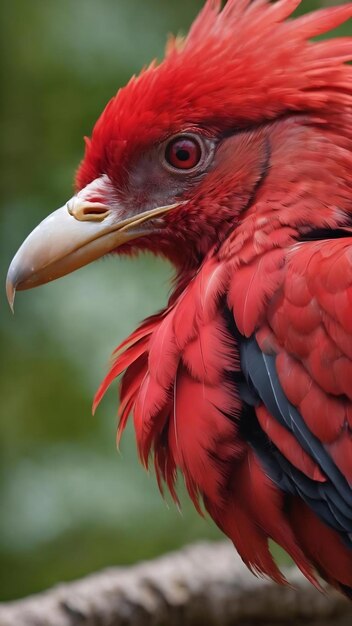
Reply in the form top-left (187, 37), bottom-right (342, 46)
top-left (7, 0), bottom-right (352, 304)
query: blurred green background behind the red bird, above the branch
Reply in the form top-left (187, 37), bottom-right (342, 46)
top-left (0, 0), bottom-right (352, 600)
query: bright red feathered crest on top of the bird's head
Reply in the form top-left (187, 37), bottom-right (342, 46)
top-left (77, 0), bottom-right (352, 187)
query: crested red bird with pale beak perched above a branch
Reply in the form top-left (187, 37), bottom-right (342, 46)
top-left (7, 0), bottom-right (352, 597)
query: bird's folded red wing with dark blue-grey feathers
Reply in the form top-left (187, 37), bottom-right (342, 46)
top-left (240, 238), bottom-right (352, 548)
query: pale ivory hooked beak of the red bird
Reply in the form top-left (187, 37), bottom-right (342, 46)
top-left (6, 196), bottom-right (181, 310)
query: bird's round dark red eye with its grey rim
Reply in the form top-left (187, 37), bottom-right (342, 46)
top-left (162, 133), bottom-right (207, 175)
